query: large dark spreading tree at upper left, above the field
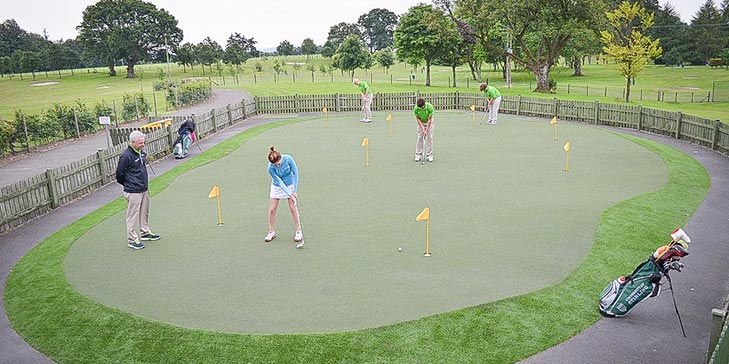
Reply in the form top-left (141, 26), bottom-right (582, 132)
top-left (77, 0), bottom-right (182, 78)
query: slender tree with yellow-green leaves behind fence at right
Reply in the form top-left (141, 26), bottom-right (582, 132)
top-left (600, 1), bottom-right (661, 102)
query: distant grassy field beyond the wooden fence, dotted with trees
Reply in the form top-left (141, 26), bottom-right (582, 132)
top-left (0, 56), bottom-right (729, 122)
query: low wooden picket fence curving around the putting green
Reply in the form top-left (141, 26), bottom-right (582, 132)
top-left (0, 92), bottom-right (729, 233)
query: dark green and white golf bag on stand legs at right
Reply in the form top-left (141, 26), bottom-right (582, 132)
top-left (599, 228), bottom-right (691, 317)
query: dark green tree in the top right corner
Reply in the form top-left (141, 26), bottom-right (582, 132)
top-left (690, 0), bottom-right (727, 64)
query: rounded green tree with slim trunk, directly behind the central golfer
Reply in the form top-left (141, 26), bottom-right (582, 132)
top-left (395, 4), bottom-right (452, 86)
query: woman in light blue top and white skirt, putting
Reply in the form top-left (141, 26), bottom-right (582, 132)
top-left (263, 145), bottom-right (303, 248)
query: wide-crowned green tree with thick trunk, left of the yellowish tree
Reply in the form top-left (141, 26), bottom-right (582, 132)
top-left (454, 0), bottom-right (605, 92)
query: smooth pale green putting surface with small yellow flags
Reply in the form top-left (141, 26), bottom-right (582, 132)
top-left (65, 112), bottom-right (668, 333)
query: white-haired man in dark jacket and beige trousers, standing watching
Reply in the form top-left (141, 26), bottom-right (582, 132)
top-left (116, 130), bottom-right (160, 249)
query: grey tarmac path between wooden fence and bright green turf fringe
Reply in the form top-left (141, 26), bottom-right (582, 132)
top-left (0, 107), bottom-right (729, 364)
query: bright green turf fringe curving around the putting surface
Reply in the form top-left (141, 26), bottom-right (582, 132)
top-left (5, 120), bottom-right (709, 363)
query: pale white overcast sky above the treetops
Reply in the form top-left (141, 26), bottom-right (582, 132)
top-left (5, 0), bottom-right (716, 50)
